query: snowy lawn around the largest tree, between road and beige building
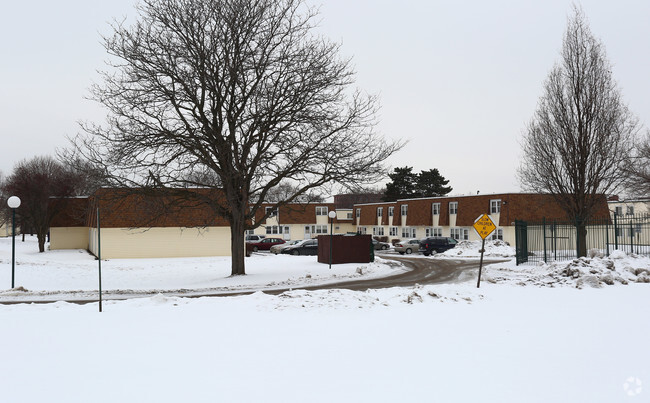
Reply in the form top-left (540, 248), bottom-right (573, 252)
top-left (0, 238), bottom-right (404, 302)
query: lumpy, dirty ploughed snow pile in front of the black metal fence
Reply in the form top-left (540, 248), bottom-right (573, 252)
top-left (482, 250), bottom-right (650, 288)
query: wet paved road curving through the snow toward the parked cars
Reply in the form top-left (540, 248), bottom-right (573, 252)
top-left (0, 254), bottom-right (506, 304)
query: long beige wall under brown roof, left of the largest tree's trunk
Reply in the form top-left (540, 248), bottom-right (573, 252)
top-left (89, 227), bottom-right (231, 259)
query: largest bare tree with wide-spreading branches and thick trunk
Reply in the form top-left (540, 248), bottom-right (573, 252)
top-left (75, 0), bottom-right (402, 275)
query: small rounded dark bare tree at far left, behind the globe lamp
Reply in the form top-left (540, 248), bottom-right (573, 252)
top-left (2, 157), bottom-right (83, 252)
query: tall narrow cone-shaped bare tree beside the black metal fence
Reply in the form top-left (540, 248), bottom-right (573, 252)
top-left (518, 7), bottom-right (639, 256)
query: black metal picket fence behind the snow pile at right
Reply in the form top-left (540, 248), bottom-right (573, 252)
top-left (515, 214), bottom-right (650, 264)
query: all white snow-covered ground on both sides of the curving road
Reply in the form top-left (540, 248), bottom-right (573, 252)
top-left (0, 235), bottom-right (650, 402)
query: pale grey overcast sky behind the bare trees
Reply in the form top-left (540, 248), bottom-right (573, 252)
top-left (0, 0), bottom-right (650, 194)
